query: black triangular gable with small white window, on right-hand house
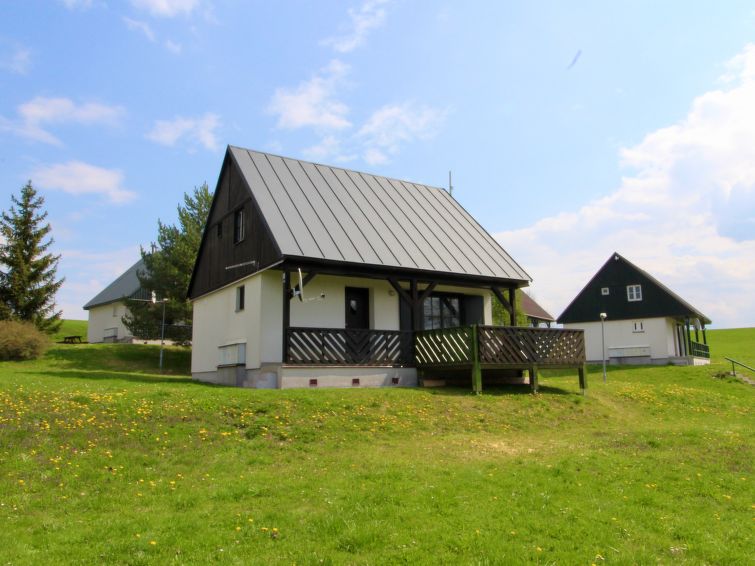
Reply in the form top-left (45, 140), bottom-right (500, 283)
top-left (558, 253), bottom-right (710, 324)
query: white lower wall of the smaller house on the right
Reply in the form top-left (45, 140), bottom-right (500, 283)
top-left (564, 317), bottom-right (676, 362)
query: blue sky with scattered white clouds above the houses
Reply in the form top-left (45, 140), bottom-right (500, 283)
top-left (0, 0), bottom-right (755, 327)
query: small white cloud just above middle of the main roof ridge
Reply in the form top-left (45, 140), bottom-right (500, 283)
top-left (357, 102), bottom-right (447, 165)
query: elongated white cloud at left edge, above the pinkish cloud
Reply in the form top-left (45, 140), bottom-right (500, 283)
top-left (0, 96), bottom-right (126, 145)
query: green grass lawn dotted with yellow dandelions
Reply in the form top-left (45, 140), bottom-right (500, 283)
top-left (0, 329), bottom-right (755, 565)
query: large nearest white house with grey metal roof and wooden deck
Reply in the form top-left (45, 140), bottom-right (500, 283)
top-left (188, 146), bottom-right (584, 390)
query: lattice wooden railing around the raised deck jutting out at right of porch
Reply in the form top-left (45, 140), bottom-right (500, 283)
top-left (415, 326), bottom-right (586, 367)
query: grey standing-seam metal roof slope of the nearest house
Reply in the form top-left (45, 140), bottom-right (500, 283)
top-left (229, 146), bottom-right (530, 281)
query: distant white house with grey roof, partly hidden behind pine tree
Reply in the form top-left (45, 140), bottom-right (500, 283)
top-left (84, 259), bottom-right (150, 343)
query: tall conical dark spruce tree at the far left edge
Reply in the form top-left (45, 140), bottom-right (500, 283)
top-left (0, 181), bottom-right (63, 333)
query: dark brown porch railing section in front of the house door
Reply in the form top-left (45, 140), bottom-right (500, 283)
top-left (286, 327), bottom-right (414, 366)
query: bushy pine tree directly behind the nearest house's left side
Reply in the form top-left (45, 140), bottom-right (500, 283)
top-left (123, 183), bottom-right (212, 338)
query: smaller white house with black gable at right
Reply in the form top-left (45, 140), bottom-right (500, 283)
top-left (558, 253), bottom-right (710, 365)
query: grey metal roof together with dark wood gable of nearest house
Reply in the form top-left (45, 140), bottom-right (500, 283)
top-left (188, 146), bottom-right (530, 298)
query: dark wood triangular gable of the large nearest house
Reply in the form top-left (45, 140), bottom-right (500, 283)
top-left (188, 152), bottom-right (281, 299)
